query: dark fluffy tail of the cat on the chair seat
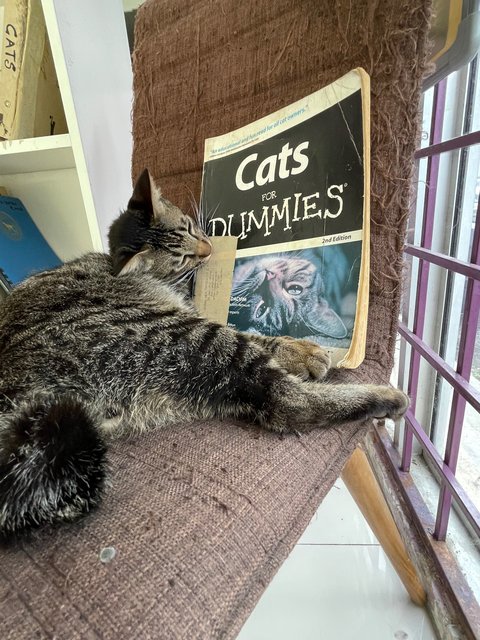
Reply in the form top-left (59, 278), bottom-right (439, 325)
top-left (0, 395), bottom-right (107, 542)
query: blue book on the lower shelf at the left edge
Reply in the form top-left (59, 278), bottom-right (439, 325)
top-left (0, 196), bottom-right (62, 289)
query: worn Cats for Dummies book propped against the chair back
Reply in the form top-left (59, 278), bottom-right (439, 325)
top-left (195, 69), bottom-right (370, 368)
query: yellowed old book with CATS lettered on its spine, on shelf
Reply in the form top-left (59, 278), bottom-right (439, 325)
top-left (0, 0), bottom-right (67, 140)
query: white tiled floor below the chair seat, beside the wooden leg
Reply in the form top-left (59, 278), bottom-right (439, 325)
top-left (238, 480), bottom-right (437, 640)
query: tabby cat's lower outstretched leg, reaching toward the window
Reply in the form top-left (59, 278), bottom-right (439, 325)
top-left (139, 319), bottom-right (408, 432)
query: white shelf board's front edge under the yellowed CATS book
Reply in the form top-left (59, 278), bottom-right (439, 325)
top-left (0, 133), bottom-right (75, 176)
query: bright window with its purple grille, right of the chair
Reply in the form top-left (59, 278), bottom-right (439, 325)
top-left (393, 58), bottom-right (480, 600)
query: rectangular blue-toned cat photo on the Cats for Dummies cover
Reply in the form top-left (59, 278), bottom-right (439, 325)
top-left (228, 243), bottom-right (361, 348)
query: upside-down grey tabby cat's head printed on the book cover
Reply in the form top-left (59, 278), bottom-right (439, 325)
top-left (232, 256), bottom-right (347, 339)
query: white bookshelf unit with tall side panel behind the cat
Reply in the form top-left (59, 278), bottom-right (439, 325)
top-left (0, 0), bottom-right (133, 260)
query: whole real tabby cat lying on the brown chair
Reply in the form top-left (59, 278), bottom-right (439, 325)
top-left (0, 171), bottom-right (408, 539)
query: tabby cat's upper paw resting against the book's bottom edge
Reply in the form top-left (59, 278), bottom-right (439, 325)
top-left (274, 336), bottom-right (330, 381)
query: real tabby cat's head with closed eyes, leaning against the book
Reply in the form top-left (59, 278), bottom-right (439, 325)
top-left (108, 169), bottom-right (212, 281)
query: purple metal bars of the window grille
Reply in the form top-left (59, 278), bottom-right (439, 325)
top-left (398, 74), bottom-right (480, 540)
